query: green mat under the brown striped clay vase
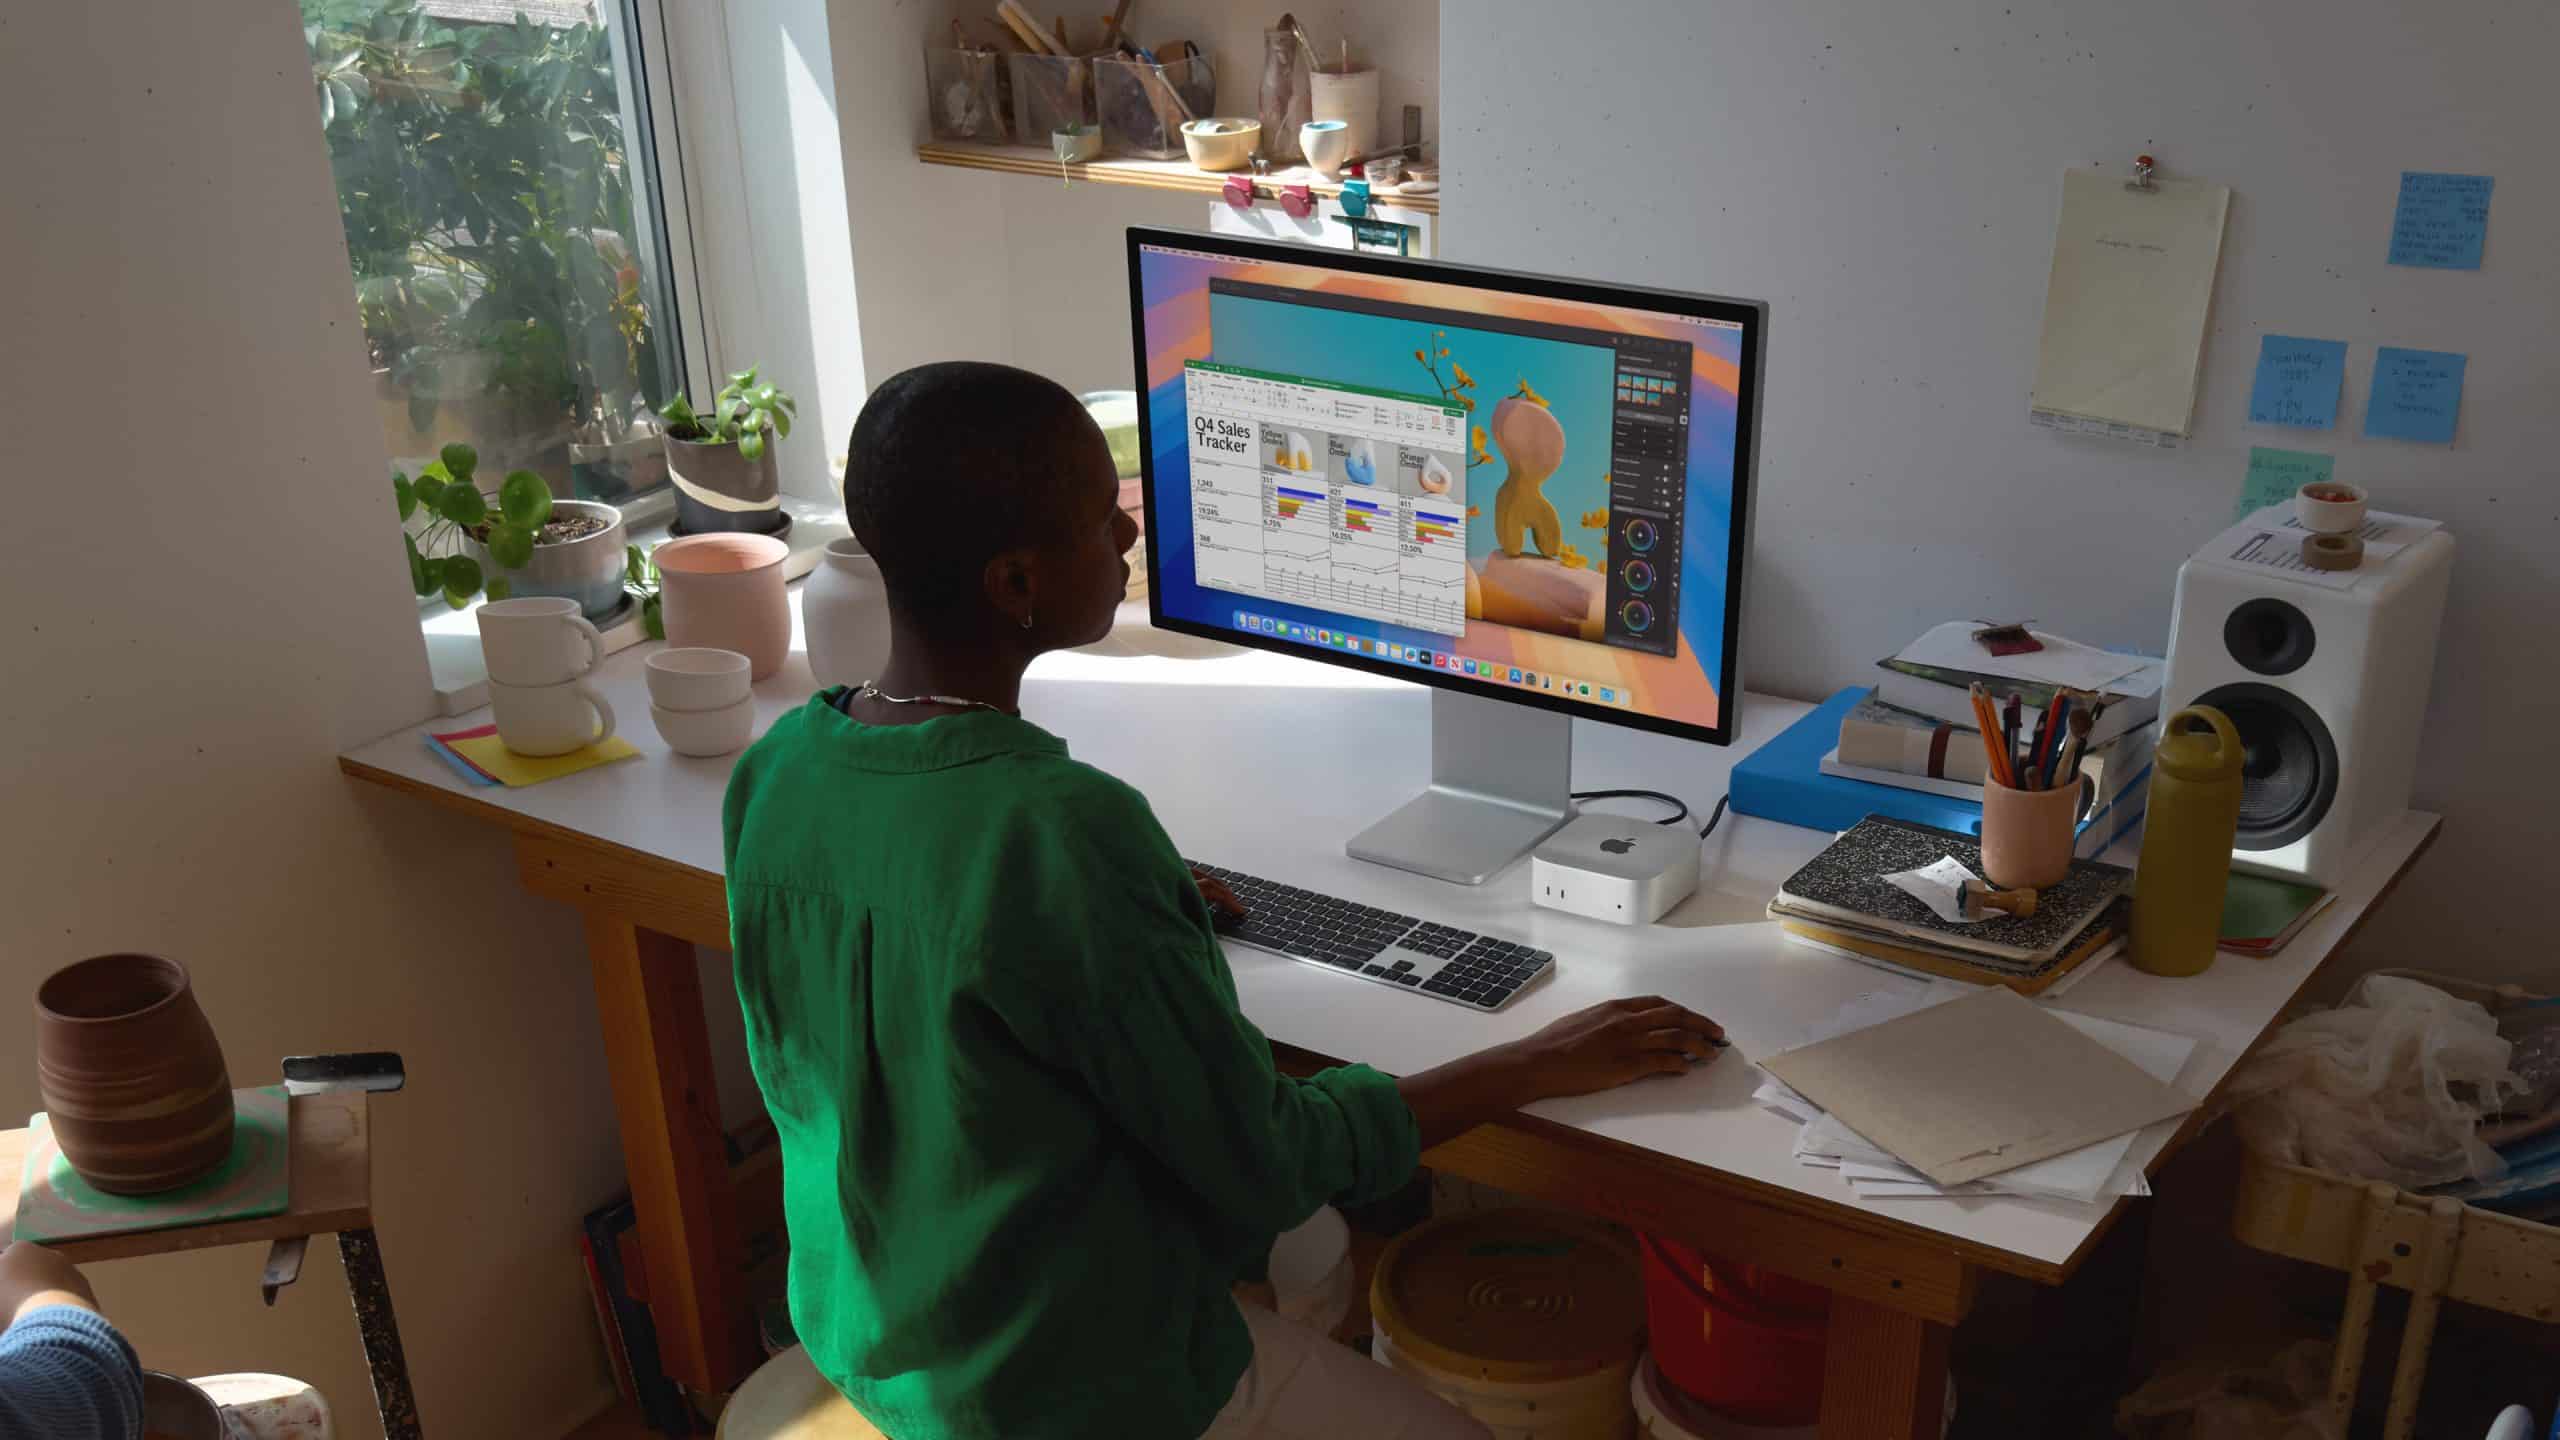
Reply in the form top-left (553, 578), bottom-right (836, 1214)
top-left (15, 1084), bottom-right (292, 1245)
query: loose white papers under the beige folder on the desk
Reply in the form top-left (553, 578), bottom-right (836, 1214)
top-left (1754, 981), bottom-right (2196, 1204)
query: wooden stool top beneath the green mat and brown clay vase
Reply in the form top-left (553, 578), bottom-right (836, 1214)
top-left (0, 1092), bottom-right (374, 1266)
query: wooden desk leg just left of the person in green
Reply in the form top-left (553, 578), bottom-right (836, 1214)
top-left (586, 912), bottom-right (753, 1394)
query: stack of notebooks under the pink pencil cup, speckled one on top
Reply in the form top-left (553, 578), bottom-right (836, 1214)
top-left (1769, 815), bottom-right (2132, 994)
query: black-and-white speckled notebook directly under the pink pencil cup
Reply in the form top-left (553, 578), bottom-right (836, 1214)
top-left (1774, 815), bottom-right (2132, 961)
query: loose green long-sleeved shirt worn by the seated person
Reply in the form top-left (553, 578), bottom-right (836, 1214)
top-left (722, 694), bottom-right (1418, 1440)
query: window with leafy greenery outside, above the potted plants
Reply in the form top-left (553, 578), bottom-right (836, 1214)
top-left (300, 0), bottom-right (689, 505)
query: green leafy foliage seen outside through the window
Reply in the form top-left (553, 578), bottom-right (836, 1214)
top-left (302, 0), bottom-right (668, 441)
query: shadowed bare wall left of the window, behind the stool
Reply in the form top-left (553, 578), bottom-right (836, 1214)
top-left (0, 0), bottom-right (660, 1437)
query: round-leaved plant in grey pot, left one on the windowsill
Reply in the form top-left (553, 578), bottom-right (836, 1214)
top-left (392, 446), bottom-right (625, 620)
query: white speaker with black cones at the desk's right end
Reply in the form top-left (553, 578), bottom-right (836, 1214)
top-left (2161, 520), bottom-right (2452, 889)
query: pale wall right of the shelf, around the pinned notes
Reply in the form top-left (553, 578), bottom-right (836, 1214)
top-left (1441, 0), bottom-right (2560, 976)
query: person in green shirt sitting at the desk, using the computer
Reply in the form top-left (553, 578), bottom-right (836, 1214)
top-left (722, 364), bottom-right (1720, 1440)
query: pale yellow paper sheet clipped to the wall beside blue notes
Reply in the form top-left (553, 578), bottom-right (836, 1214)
top-left (2033, 169), bottom-right (2232, 436)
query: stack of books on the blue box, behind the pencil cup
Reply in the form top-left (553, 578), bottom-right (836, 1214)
top-left (1820, 620), bottom-right (2163, 856)
